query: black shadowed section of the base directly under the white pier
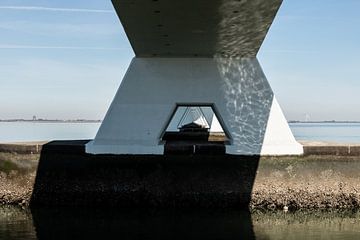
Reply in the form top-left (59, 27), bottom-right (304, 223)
top-left (30, 141), bottom-right (259, 207)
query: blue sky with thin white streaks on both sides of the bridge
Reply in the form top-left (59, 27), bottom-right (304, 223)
top-left (0, 0), bottom-right (360, 121)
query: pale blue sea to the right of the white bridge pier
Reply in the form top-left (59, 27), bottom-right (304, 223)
top-left (289, 123), bottom-right (360, 143)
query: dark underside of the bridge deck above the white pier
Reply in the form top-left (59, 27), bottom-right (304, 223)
top-left (113, 0), bottom-right (282, 57)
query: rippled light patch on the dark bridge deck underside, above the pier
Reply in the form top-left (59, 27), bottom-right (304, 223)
top-left (217, 0), bottom-right (282, 57)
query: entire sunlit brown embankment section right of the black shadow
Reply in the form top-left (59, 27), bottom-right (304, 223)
top-left (250, 155), bottom-right (360, 210)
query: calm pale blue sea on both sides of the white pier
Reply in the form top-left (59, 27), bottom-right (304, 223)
top-left (0, 122), bottom-right (360, 143)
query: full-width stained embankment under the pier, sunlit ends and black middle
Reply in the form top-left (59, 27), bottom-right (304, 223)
top-left (0, 142), bottom-right (360, 210)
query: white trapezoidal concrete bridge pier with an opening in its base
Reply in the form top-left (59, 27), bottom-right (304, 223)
top-left (86, 57), bottom-right (302, 155)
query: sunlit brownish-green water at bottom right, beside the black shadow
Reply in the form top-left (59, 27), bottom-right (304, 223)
top-left (252, 211), bottom-right (360, 240)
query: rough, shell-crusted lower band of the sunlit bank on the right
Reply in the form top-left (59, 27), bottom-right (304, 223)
top-left (250, 183), bottom-right (360, 211)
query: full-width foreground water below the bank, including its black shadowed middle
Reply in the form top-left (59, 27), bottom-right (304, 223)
top-left (0, 207), bottom-right (360, 240)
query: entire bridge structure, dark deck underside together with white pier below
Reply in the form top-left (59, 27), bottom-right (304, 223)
top-left (86, 0), bottom-right (303, 155)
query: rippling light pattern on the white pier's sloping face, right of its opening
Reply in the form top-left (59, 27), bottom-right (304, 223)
top-left (216, 57), bottom-right (273, 154)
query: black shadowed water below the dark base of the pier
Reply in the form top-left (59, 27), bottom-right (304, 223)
top-left (32, 208), bottom-right (255, 239)
